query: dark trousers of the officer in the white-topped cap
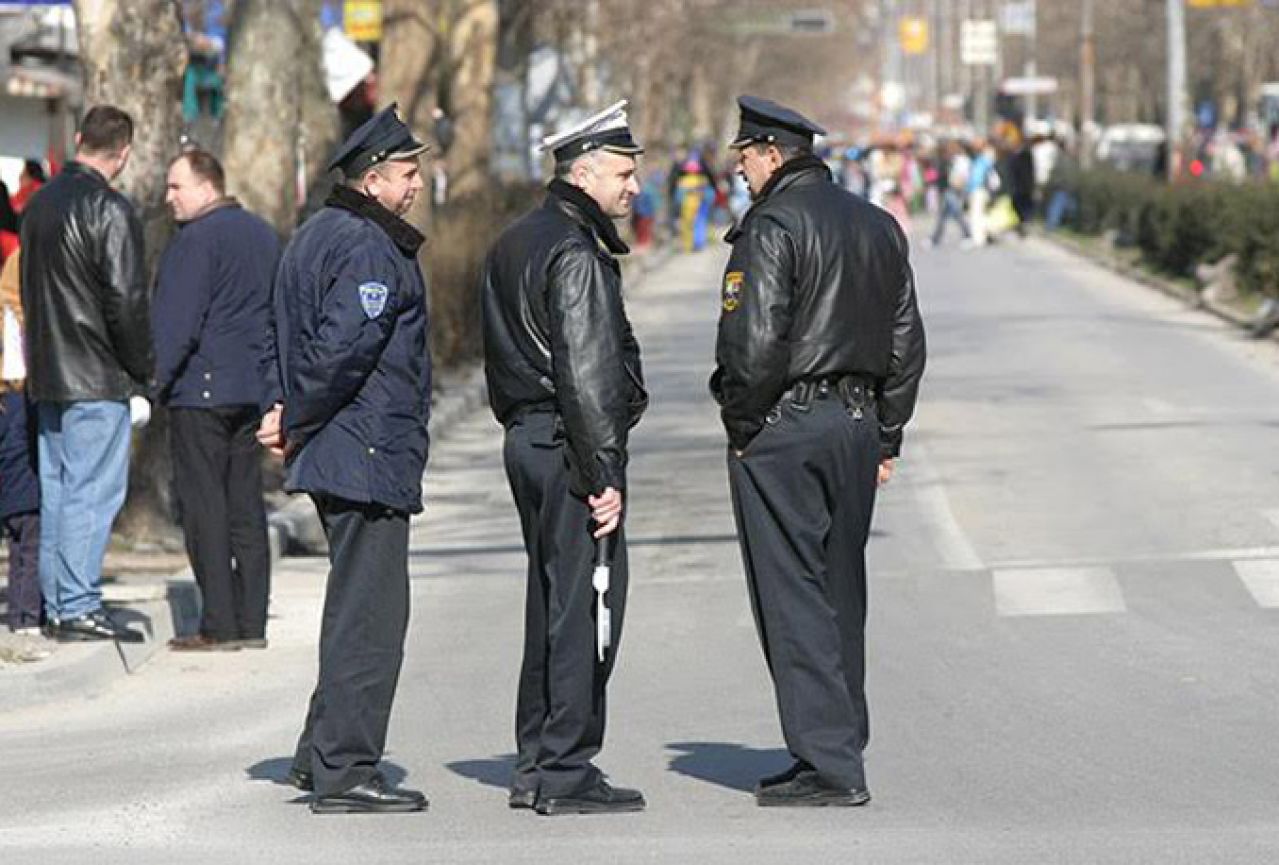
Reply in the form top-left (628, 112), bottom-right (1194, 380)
top-left (504, 412), bottom-right (627, 797)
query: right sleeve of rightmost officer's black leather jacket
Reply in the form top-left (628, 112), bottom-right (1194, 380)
top-left (879, 229), bottom-right (927, 458)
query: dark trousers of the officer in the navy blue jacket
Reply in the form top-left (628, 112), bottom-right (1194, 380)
top-left (293, 495), bottom-right (409, 796)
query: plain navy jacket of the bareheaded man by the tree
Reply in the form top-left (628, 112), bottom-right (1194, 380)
top-left (151, 198), bottom-right (280, 408)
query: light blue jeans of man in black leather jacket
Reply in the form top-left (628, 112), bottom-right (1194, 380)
top-left (37, 399), bottom-right (129, 619)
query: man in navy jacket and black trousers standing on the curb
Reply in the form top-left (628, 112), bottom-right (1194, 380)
top-left (151, 150), bottom-right (280, 651)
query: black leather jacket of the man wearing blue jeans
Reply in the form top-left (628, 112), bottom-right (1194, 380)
top-left (22, 163), bottom-right (153, 402)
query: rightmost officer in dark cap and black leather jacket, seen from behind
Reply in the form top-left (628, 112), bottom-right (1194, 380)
top-left (711, 96), bottom-right (925, 805)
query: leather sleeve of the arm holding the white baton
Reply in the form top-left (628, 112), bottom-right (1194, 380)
top-left (546, 247), bottom-right (633, 495)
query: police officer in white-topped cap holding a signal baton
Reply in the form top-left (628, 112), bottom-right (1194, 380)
top-left (482, 101), bottom-right (647, 815)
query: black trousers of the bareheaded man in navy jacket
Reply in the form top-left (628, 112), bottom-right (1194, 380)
top-left (169, 406), bottom-right (271, 640)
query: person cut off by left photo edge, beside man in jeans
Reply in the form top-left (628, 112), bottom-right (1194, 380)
top-left (0, 243), bottom-right (42, 636)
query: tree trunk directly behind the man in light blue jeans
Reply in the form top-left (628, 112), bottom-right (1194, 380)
top-left (74, 0), bottom-right (187, 539)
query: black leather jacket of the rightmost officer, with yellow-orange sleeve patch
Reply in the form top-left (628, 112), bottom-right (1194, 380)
top-left (711, 156), bottom-right (925, 457)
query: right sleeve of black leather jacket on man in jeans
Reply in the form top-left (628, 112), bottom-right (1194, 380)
top-left (98, 197), bottom-right (153, 385)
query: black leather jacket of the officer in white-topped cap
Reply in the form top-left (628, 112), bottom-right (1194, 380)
top-left (481, 180), bottom-right (648, 496)
